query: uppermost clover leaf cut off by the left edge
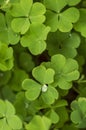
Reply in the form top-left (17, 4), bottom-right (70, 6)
top-left (0, 13), bottom-right (20, 44)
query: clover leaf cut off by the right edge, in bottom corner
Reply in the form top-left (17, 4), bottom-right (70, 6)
top-left (71, 97), bottom-right (86, 128)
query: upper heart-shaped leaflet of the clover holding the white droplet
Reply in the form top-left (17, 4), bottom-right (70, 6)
top-left (32, 65), bottom-right (55, 84)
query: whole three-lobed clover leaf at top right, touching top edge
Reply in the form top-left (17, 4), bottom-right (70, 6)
top-left (44, 0), bottom-right (79, 32)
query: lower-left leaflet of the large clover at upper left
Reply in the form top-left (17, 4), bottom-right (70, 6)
top-left (11, 18), bottom-right (30, 34)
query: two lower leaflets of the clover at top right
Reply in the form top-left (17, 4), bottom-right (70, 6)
top-left (46, 7), bottom-right (79, 32)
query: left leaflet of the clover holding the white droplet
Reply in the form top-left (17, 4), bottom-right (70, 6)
top-left (22, 79), bottom-right (41, 101)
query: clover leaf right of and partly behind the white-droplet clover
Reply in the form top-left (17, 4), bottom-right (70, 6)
top-left (43, 54), bottom-right (79, 90)
